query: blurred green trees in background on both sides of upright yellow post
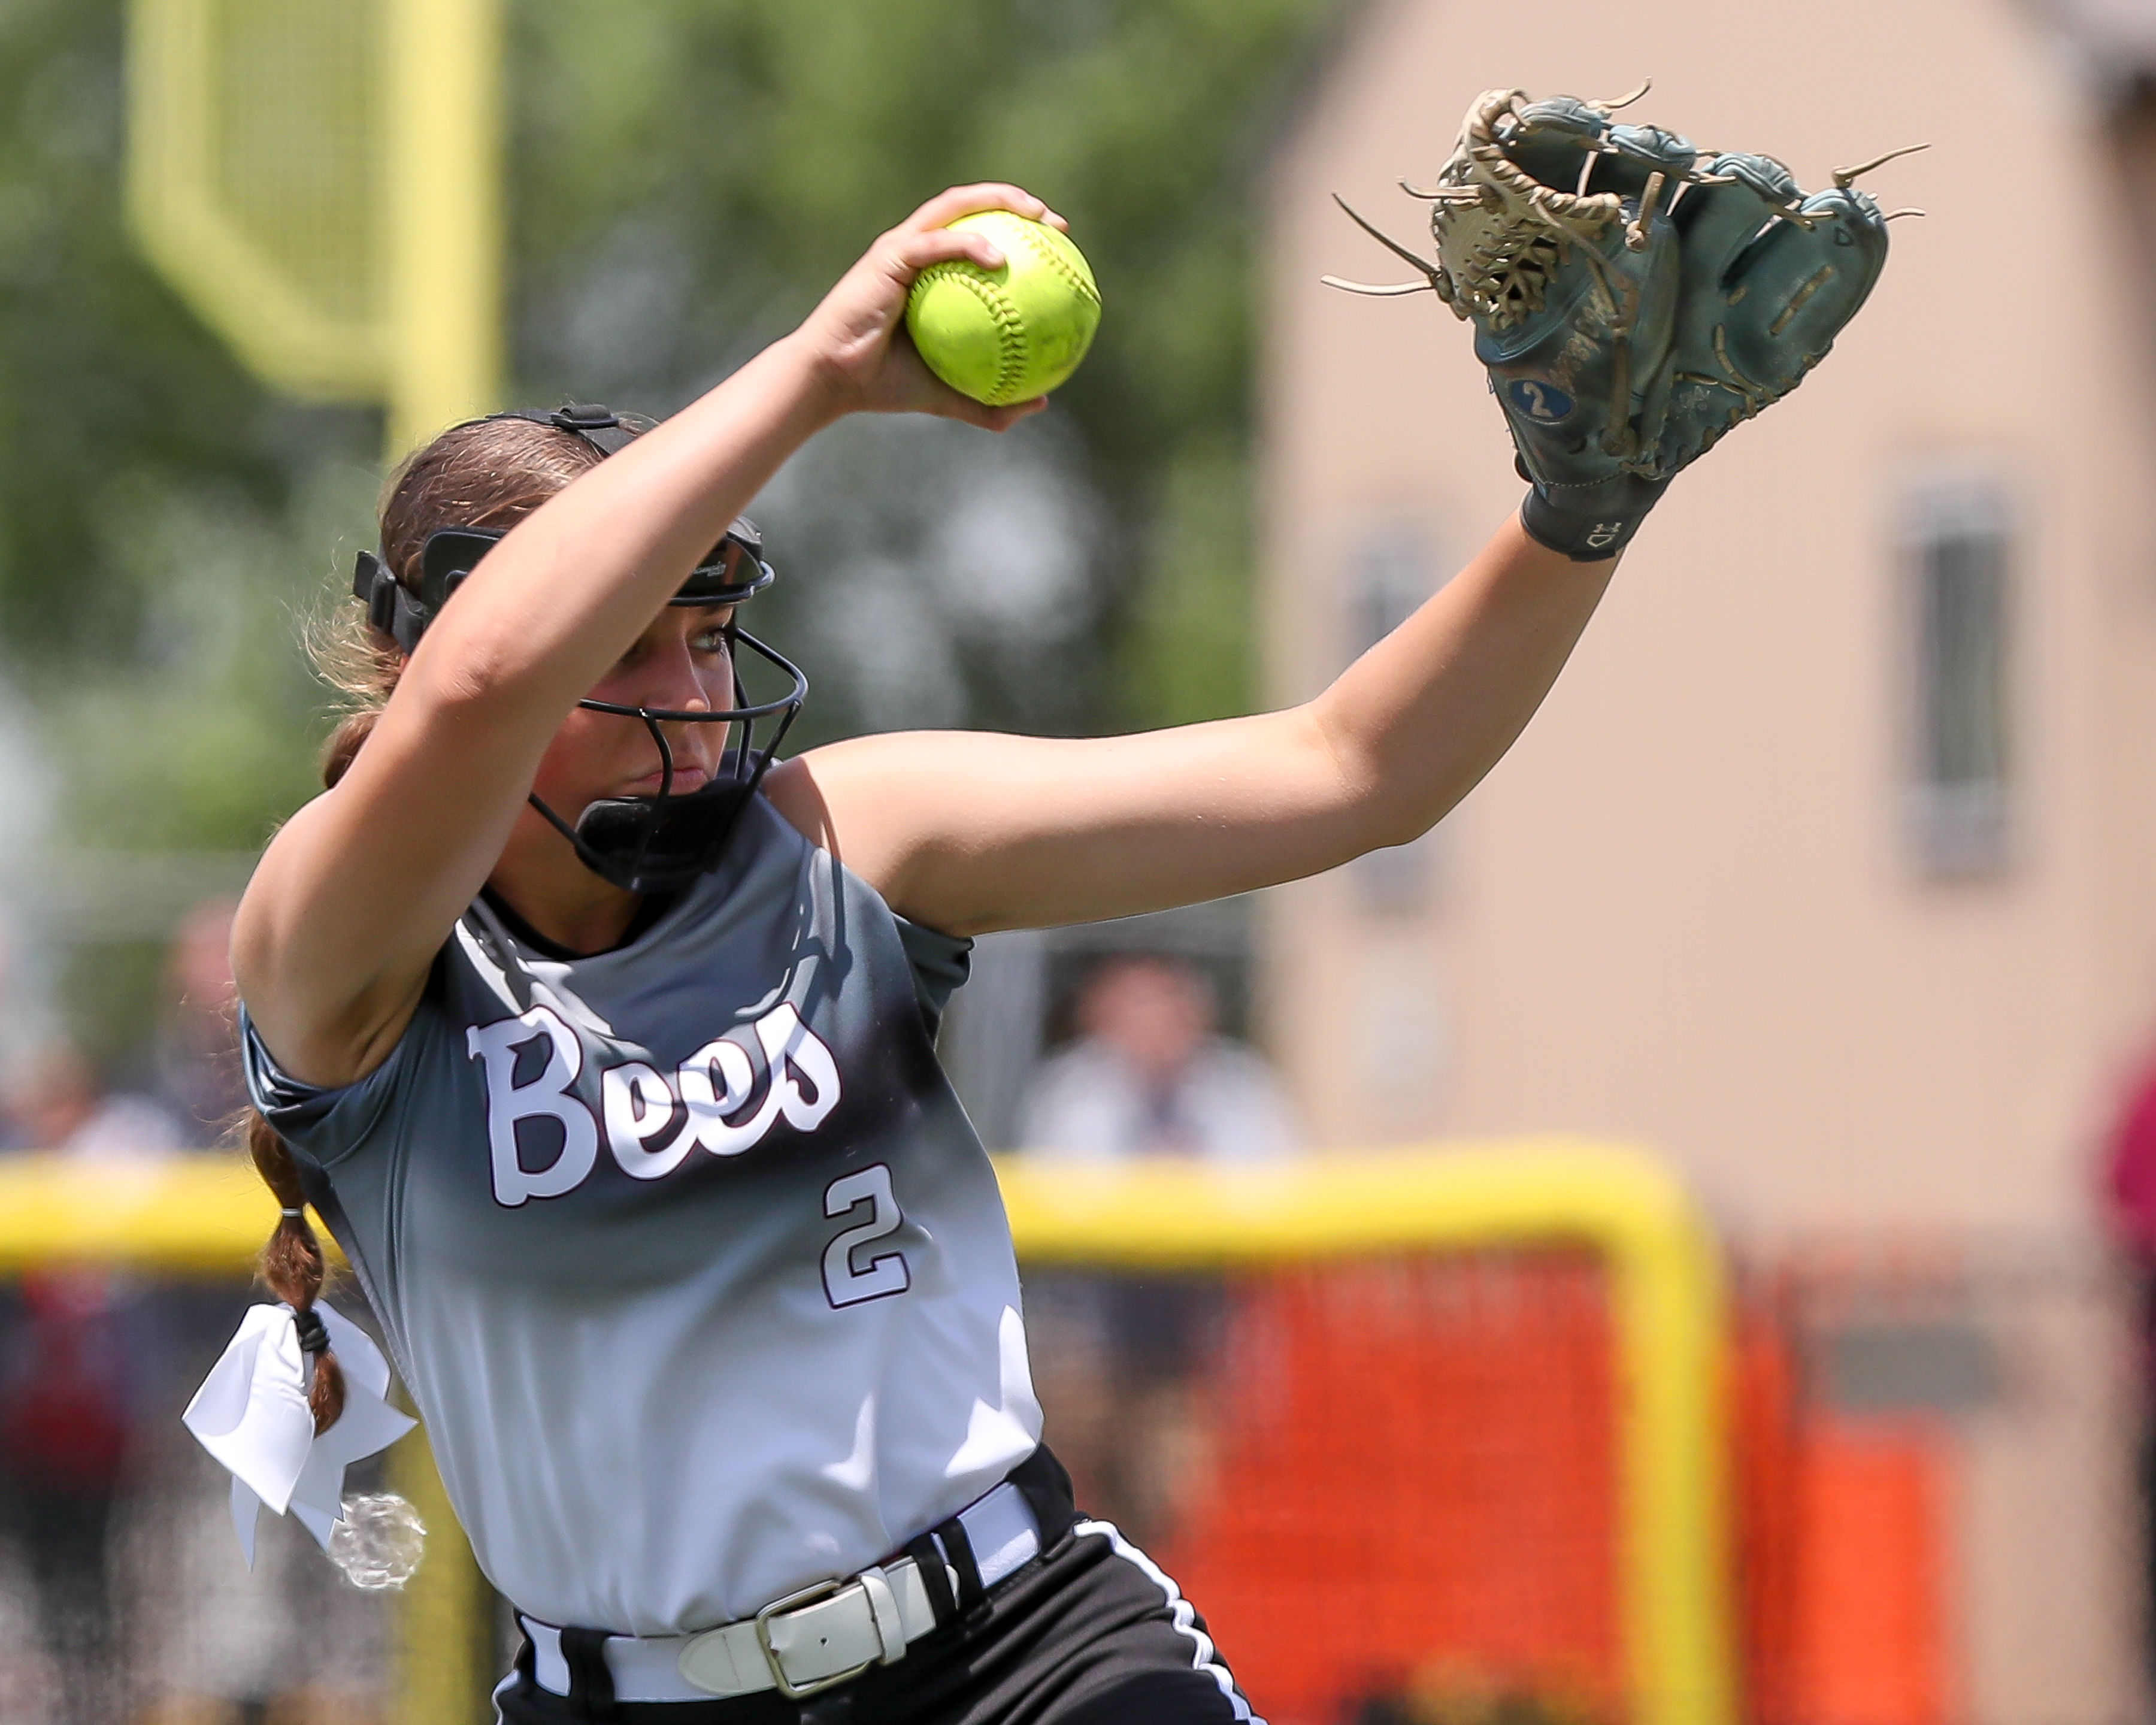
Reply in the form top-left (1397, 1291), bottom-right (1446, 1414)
top-left (0, 0), bottom-right (1345, 1065)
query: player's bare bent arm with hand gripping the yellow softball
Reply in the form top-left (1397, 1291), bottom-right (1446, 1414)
top-left (233, 186), bottom-right (1048, 1085)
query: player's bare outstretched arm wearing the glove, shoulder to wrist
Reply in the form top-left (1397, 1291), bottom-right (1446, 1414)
top-left (768, 520), bottom-right (1615, 934)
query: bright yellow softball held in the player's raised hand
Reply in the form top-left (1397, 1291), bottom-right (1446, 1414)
top-left (906, 209), bottom-right (1100, 407)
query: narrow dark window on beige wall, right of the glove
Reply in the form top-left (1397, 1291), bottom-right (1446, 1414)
top-left (1908, 481), bottom-right (2013, 876)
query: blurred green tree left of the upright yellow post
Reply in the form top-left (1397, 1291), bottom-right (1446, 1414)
top-left (0, 0), bottom-right (380, 848)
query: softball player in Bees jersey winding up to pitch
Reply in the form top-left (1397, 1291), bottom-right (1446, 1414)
top-left (235, 186), bottom-right (1615, 1725)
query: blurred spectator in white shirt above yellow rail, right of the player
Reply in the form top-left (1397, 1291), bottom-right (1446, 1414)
top-left (1022, 957), bottom-right (1298, 1162)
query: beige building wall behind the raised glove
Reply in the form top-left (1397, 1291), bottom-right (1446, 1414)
top-left (1264, 0), bottom-right (2156, 1233)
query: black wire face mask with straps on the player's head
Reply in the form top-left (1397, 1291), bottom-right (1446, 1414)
top-left (352, 407), bottom-right (808, 892)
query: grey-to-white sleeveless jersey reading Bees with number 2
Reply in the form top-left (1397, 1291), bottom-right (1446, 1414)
top-left (248, 798), bottom-right (1039, 1635)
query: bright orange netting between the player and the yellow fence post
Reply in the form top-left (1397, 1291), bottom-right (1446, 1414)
top-left (1162, 1255), bottom-right (1619, 1723)
